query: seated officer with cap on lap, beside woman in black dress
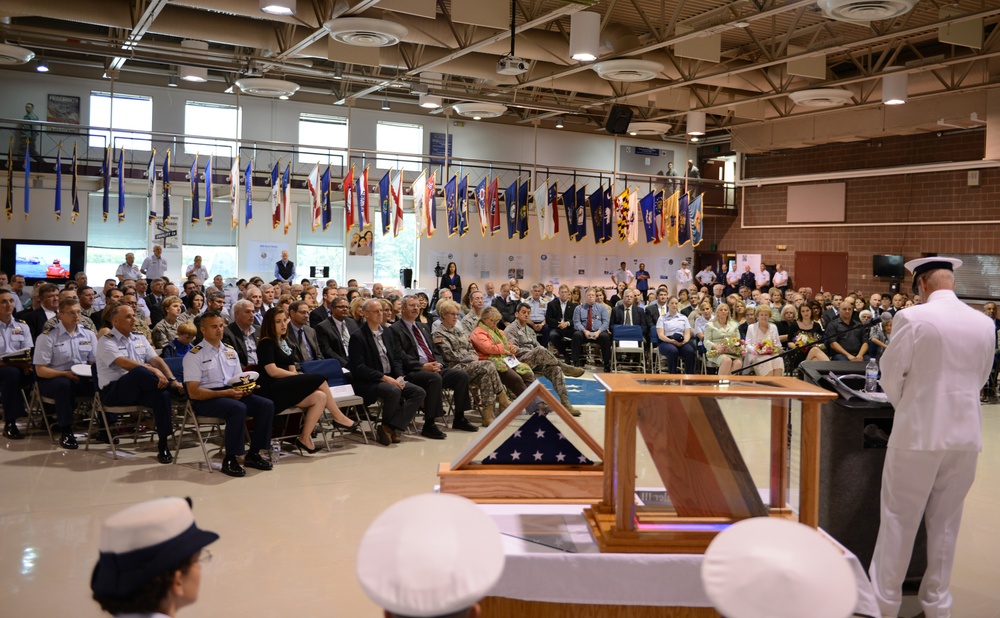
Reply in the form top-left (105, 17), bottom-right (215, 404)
top-left (184, 311), bottom-right (274, 477)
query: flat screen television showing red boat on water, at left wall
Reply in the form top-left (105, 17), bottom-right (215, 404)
top-left (0, 238), bottom-right (86, 285)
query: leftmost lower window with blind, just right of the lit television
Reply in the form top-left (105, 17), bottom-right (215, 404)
top-left (87, 193), bottom-right (149, 282)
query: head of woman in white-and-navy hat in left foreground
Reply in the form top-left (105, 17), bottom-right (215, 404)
top-left (90, 498), bottom-right (219, 618)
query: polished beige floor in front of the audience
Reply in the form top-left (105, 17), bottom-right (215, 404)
top-left (0, 374), bottom-right (1000, 618)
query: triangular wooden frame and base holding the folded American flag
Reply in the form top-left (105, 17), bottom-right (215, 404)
top-left (438, 380), bottom-right (604, 504)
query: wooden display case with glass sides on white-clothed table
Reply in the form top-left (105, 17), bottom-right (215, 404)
top-left (584, 373), bottom-right (836, 553)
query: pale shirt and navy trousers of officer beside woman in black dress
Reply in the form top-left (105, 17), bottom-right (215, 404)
top-left (184, 341), bottom-right (274, 455)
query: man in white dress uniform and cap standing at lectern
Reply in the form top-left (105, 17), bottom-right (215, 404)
top-left (869, 257), bottom-right (994, 618)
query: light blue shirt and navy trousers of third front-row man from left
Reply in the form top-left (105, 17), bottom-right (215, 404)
top-left (96, 328), bottom-right (173, 440)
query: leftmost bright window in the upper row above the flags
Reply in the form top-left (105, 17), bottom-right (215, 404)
top-left (89, 92), bottom-right (153, 152)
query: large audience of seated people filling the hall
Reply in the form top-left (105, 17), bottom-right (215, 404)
top-left (0, 258), bottom-right (1000, 462)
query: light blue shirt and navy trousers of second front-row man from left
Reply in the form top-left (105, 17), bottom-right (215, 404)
top-left (34, 322), bottom-right (97, 431)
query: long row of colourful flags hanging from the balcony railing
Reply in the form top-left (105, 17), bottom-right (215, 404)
top-left (6, 144), bottom-right (704, 246)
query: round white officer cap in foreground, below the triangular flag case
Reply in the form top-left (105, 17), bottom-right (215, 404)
top-left (357, 494), bottom-right (504, 617)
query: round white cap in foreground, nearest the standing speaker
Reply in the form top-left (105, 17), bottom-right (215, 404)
top-left (701, 517), bottom-right (858, 618)
